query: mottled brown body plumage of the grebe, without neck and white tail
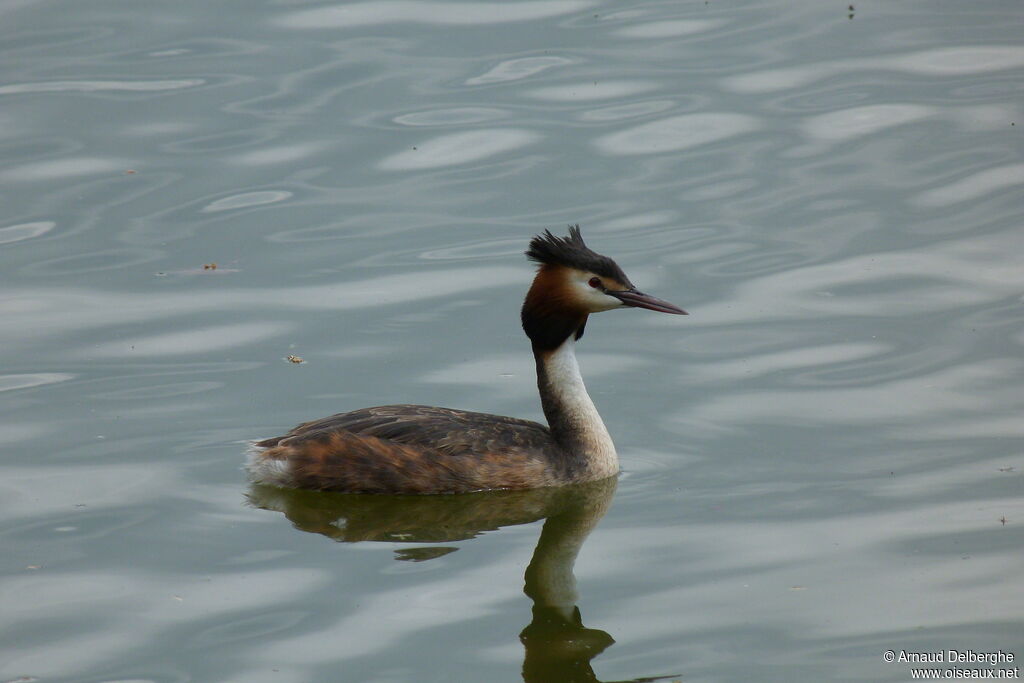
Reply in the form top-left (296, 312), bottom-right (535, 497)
top-left (250, 405), bottom-right (567, 494)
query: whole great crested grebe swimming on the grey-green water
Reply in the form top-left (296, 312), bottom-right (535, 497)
top-left (247, 225), bottom-right (686, 494)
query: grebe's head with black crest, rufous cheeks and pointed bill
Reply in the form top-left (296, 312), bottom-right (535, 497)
top-left (522, 225), bottom-right (686, 350)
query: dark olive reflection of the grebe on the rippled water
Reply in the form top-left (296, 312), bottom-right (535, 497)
top-left (249, 477), bottom-right (674, 683)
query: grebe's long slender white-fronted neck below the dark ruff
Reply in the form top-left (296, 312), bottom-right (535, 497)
top-left (534, 335), bottom-right (618, 479)
